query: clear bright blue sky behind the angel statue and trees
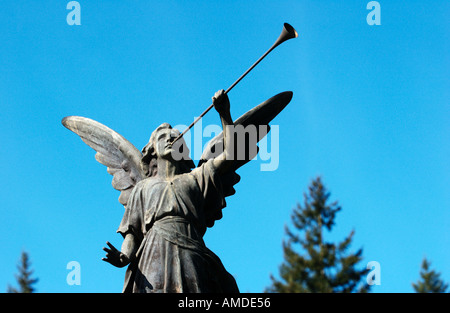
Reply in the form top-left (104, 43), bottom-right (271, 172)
top-left (0, 0), bottom-right (450, 292)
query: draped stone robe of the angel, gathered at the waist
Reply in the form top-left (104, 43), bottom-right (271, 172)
top-left (117, 160), bottom-right (239, 293)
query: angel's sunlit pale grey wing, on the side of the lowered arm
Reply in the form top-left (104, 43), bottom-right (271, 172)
top-left (62, 116), bottom-right (145, 206)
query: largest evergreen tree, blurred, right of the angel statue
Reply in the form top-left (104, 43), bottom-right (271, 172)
top-left (266, 177), bottom-right (370, 293)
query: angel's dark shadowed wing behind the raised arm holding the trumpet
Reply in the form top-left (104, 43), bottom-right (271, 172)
top-left (198, 91), bottom-right (293, 196)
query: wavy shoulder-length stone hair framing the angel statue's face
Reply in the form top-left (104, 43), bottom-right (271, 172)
top-left (141, 123), bottom-right (195, 177)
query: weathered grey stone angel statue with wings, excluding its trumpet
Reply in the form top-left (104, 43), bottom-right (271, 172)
top-left (62, 90), bottom-right (292, 293)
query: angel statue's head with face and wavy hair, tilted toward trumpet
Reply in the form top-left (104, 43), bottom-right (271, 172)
top-left (141, 123), bottom-right (195, 177)
